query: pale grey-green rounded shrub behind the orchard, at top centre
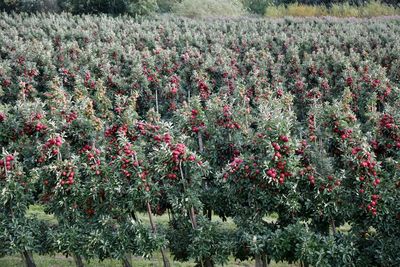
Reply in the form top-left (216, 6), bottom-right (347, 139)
top-left (173, 0), bottom-right (245, 18)
